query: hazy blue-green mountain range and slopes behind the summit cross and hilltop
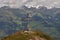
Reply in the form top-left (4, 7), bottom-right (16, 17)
top-left (0, 6), bottom-right (60, 38)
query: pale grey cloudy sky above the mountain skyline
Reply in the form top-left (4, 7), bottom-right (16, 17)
top-left (0, 0), bottom-right (60, 8)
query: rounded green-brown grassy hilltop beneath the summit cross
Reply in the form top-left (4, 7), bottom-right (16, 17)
top-left (2, 31), bottom-right (54, 40)
